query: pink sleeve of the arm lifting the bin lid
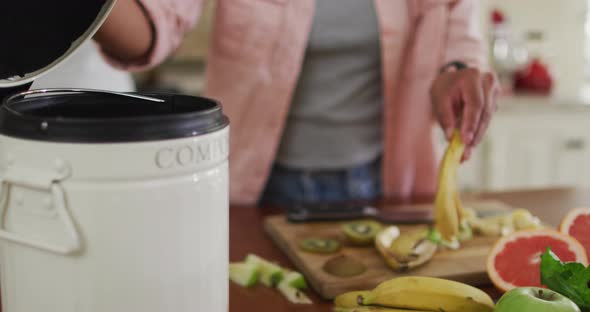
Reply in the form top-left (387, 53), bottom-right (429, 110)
top-left (103, 0), bottom-right (205, 71)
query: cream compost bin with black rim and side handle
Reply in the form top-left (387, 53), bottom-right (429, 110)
top-left (0, 90), bottom-right (229, 312)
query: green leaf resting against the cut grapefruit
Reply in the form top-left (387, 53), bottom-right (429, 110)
top-left (541, 247), bottom-right (590, 312)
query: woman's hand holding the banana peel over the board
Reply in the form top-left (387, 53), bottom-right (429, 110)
top-left (430, 68), bottom-right (499, 161)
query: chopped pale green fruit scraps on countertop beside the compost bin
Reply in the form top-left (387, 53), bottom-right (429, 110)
top-left (229, 254), bottom-right (312, 304)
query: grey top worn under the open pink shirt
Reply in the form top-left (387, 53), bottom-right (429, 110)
top-left (277, 0), bottom-right (383, 169)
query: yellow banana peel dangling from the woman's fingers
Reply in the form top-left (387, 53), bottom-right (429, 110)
top-left (434, 131), bottom-right (465, 241)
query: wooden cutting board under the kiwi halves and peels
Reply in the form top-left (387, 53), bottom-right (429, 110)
top-left (265, 201), bottom-right (510, 299)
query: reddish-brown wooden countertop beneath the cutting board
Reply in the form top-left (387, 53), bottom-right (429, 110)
top-left (229, 189), bottom-right (590, 312)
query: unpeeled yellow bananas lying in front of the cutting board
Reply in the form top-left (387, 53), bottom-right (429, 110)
top-left (334, 276), bottom-right (494, 312)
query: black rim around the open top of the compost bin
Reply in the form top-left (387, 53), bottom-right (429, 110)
top-left (0, 94), bottom-right (229, 143)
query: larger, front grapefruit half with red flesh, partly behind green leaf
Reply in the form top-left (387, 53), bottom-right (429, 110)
top-left (486, 229), bottom-right (588, 291)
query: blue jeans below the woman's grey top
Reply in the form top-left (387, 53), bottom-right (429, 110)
top-left (260, 158), bottom-right (381, 206)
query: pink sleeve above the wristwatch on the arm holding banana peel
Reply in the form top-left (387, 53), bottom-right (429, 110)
top-left (444, 0), bottom-right (489, 69)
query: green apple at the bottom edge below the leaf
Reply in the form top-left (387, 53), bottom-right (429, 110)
top-left (494, 287), bottom-right (580, 312)
